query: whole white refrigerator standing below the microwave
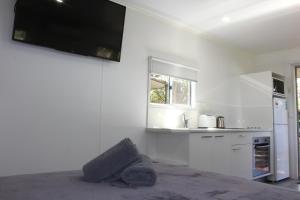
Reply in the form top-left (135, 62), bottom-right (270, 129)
top-left (271, 97), bottom-right (290, 181)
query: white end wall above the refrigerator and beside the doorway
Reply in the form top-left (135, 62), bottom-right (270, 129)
top-left (255, 48), bottom-right (300, 178)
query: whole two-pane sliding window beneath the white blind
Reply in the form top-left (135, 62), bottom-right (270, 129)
top-left (150, 73), bottom-right (195, 106)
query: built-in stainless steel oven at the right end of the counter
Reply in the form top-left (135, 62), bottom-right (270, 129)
top-left (252, 137), bottom-right (271, 178)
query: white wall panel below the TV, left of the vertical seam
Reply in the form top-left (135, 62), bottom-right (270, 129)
top-left (0, 0), bottom-right (101, 176)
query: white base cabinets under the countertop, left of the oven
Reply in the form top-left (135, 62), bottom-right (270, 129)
top-left (189, 133), bottom-right (252, 179)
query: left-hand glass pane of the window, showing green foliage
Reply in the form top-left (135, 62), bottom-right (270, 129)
top-left (150, 74), bottom-right (169, 104)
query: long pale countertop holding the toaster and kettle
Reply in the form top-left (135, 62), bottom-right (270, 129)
top-left (146, 128), bottom-right (272, 133)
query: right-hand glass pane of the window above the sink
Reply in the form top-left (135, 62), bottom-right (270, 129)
top-left (171, 78), bottom-right (191, 105)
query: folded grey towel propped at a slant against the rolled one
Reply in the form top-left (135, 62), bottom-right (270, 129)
top-left (83, 138), bottom-right (140, 182)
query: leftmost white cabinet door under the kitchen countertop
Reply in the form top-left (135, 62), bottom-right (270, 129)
top-left (189, 134), bottom-right (214, 171)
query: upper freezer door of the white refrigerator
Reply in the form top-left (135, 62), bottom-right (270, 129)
top-left (273, 98), bottom-right (288, 124)
